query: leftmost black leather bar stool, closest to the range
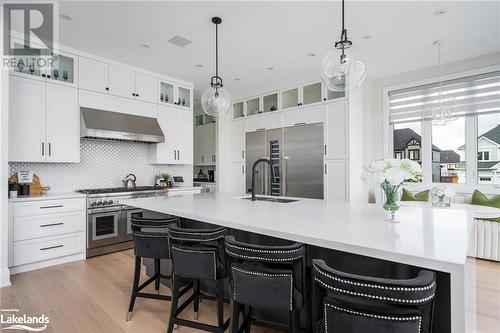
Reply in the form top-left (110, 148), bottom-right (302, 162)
top-left (127, 212), bottom-right (189, 321)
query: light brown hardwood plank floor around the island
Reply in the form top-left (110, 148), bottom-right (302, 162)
top-left (0, 251), bottom-right (500, 333)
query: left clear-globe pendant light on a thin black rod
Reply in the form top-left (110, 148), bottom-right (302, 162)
top-left (201, 17), bottom-right (231, 117)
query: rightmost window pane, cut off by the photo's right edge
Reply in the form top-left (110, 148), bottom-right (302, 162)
top-left (477, 113), bottom-right (500, 184)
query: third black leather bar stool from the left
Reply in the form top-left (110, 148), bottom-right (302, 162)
top-left (225, 236), bottom-right (307, 333)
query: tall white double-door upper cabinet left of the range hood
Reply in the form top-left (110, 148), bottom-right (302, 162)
top-left (9, 75), bottom-right (80, 162)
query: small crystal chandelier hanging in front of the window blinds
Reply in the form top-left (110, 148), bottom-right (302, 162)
top-left (424, 39), bottom-right (458, 126)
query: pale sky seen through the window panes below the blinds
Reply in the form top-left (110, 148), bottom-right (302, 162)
top-left (394, 113), bottom-right (500, 151)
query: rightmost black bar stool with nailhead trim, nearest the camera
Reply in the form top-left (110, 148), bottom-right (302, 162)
top-left (312, 259), bottom-right (436, 333)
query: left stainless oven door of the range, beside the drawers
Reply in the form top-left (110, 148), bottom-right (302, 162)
top-left (87, 208), bottom-right (122, 248)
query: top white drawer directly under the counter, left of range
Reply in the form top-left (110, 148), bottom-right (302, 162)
top-left (14, 198), bottom-right (86, 218)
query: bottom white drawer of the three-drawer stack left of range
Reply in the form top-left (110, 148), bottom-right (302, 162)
top-left (13, 232), bottom-right (85, 266)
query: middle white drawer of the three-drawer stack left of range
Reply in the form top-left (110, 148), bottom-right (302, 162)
top-left (14, 211), bottom-right (85, 241)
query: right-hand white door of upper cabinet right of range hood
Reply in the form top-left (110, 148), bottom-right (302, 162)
top-left (177, 110), bottom-right (193, 164)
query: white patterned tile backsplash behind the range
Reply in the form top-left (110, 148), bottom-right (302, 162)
top-left (9, 139), bottom-right (193, 192)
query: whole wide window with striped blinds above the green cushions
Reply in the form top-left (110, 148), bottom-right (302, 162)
top-left (387, 70), bottom-right (500, 188)
